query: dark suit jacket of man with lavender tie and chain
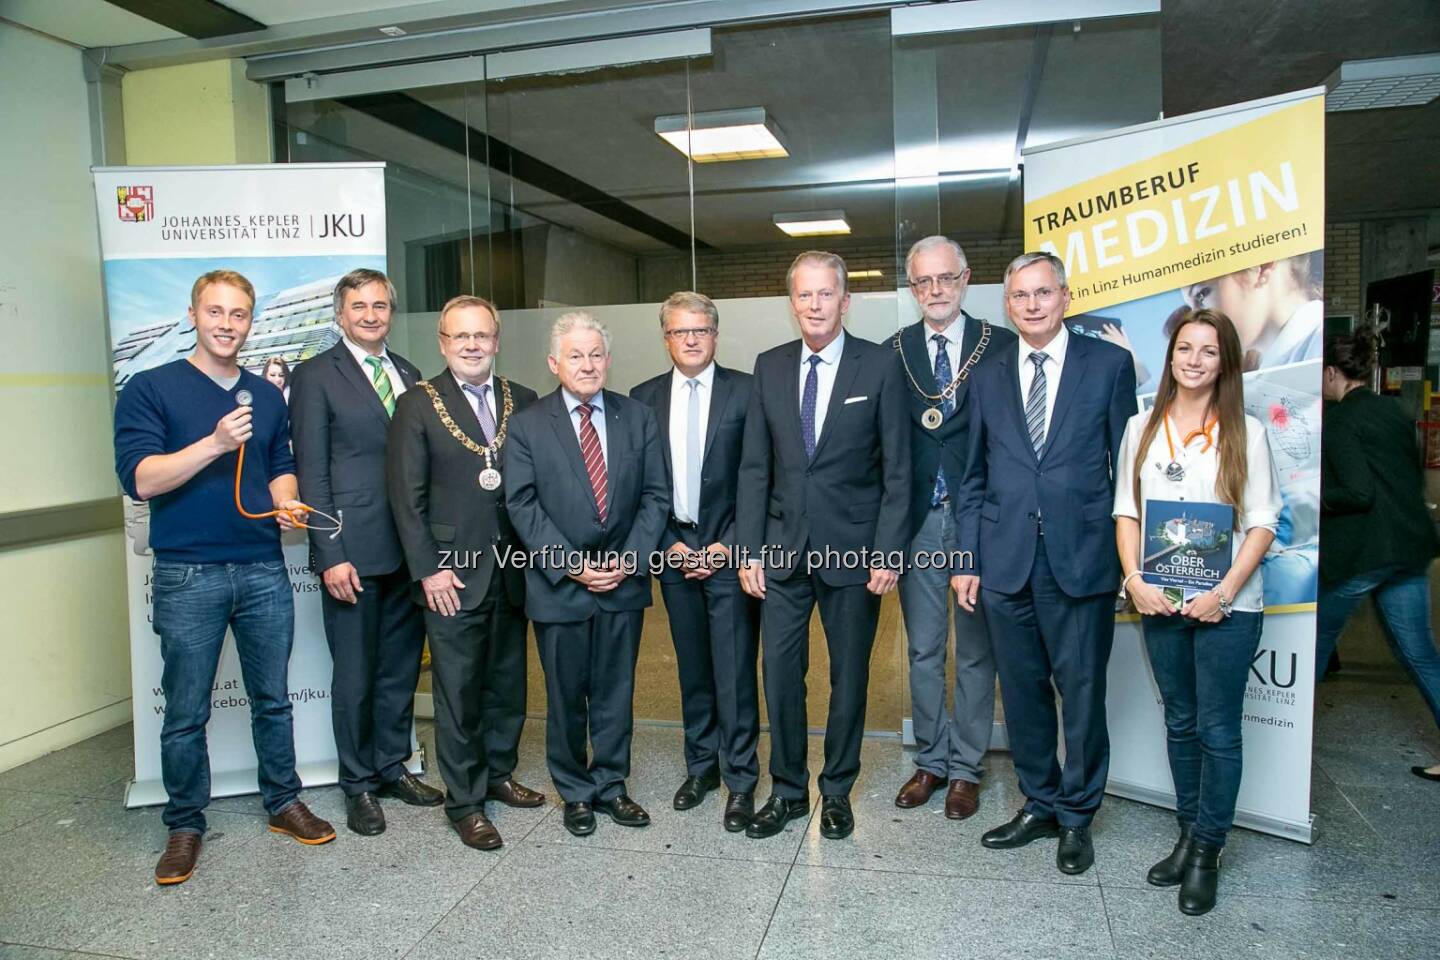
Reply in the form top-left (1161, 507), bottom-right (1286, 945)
top-left (386, 370), bottom-right (536, 610)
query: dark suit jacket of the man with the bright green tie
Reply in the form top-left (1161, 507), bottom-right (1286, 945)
top-left (289, 341), bottom-right (420, 577)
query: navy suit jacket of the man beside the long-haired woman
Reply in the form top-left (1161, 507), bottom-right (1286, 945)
top-left (952, 334), bottom-right (1138, 597)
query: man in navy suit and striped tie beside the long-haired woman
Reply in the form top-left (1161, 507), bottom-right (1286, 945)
top-left (952, 253), bottom-right (1135, 874)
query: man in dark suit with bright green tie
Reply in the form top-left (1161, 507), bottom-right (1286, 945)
top-left (289, 269), bottom-right (444, 836)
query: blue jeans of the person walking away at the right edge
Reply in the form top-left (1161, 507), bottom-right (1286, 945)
top-left (1315, 567), bottom-right (1440, 725)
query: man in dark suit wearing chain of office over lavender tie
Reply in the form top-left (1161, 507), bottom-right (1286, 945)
top-left (386, 296), bottom-right (544, 851)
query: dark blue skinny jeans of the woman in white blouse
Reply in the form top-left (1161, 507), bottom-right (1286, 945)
top-left (1140, 612), bottom-right (1264, 846)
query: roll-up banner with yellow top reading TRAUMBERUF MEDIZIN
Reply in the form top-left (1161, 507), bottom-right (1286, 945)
top-left (1025, 89), bottom-right (1325, 842)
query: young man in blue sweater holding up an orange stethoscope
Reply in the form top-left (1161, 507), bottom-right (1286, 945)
top-left (115, 271), bottom-right (336, 884)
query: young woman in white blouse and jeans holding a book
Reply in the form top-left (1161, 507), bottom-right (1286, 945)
top-left (1115, 309), bottom-right (1280, 915)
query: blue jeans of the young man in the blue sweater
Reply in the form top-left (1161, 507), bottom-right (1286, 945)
top-left (150, 560), bottom-right (300, 833)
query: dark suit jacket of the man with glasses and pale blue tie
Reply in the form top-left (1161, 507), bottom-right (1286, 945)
top-left (631, 364), bottom-right (755, 583)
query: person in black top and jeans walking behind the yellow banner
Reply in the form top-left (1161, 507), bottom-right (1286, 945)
top-left (1315, 331), bottom-right (1440, 782)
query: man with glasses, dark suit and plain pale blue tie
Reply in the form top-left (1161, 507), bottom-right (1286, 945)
top-left (631, 291), bottom-right (760, 833)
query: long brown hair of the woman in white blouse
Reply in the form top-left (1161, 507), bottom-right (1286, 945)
top-left (1133, 309), bottom-right (1248, 530)
